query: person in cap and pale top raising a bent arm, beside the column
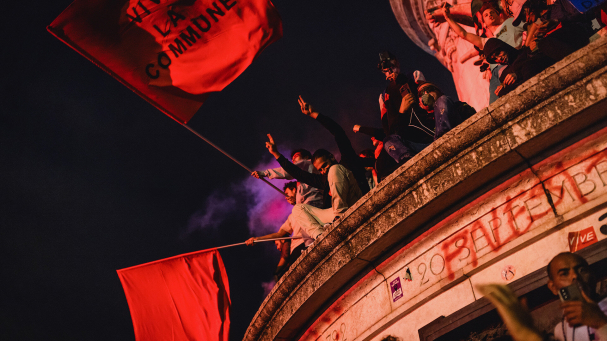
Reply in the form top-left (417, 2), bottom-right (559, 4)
top-left (443, 2), bottom-right (525, 104)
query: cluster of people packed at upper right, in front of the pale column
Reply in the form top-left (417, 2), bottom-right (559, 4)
top-left (426, 0), bottom-right (607, 103)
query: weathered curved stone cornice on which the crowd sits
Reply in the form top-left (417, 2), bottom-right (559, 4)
top-left (244, 40), bottom-right (607, 340)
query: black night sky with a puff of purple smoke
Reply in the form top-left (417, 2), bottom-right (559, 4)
top-left (0, 0), bottom-right (455, 340)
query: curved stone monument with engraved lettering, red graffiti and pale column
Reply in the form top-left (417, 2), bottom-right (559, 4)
top-left (244, 10), bottom-right (607, 341)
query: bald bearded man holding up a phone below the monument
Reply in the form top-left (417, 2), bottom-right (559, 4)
top-left (546, 252), bottom-right (607, 341)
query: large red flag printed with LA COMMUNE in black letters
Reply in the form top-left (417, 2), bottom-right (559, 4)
top-left (48, 0), bottom-right (282, 123)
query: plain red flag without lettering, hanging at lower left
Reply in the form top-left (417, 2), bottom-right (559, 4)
top-left (117, 249), bottom-right (230, 341)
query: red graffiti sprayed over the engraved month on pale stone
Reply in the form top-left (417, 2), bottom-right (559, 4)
top-left (440, 150), bottom-right (607, 278)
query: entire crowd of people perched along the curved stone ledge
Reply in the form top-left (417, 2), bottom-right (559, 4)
top-left (246, 0), bottom-right (607, 318)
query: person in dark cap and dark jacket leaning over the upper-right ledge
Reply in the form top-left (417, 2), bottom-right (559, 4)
top-left (483, 38), bottom-right (554, 97)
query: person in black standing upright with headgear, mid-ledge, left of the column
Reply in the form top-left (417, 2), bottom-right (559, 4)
top-left (377, 51), bottom-right (434, 164)
